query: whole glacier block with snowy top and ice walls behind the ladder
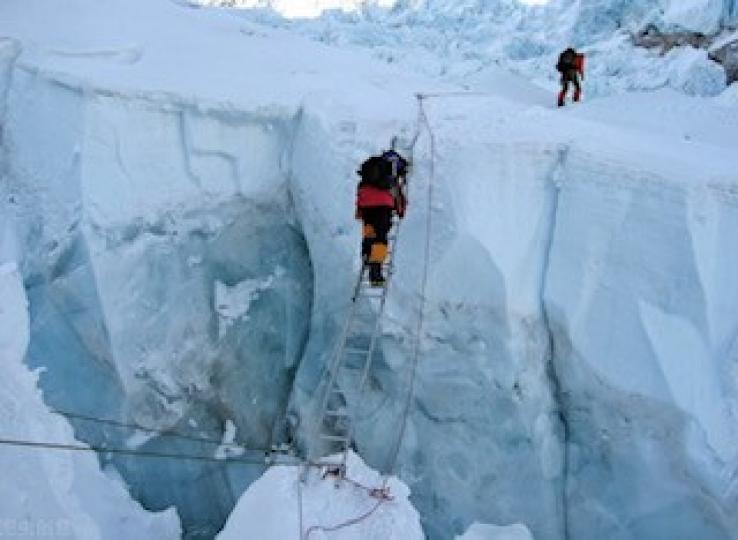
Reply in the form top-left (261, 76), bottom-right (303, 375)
top-left (0, 0), bottom-right (738, 539)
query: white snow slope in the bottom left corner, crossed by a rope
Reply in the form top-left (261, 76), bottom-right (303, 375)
top-left (0, 262), bottom-right (180, 540)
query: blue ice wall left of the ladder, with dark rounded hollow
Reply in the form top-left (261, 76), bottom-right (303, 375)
top-left (4, 53), bottom-right (312, 534)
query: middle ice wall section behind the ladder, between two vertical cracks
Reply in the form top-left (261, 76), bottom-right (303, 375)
top-left (292, 94), bottom-right (563, 538)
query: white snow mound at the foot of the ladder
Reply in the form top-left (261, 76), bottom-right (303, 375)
top-left (218, 452), bottom-right (425, 540)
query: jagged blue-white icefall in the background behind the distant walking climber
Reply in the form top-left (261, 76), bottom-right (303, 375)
top-left (220, 0), bottom-right (738, 97)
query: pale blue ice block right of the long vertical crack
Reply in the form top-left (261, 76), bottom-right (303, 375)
top-left (546, 147), bottom-right (738, 538)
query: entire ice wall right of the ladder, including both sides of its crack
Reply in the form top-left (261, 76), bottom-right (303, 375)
top-left (293, 89), bottom-right (738, 539)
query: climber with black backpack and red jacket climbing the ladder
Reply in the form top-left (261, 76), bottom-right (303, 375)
top-left (356, 150), bottom-right (408, 287)
